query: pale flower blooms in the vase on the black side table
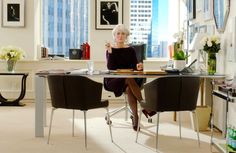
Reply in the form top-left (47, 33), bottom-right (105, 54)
top-left (0, 46), bottom-right (25, 61)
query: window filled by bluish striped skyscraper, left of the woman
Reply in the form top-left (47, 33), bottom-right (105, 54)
top-left (41, 0), bottom-right (88, 56)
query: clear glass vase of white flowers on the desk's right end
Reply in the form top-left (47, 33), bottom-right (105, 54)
top-left (201, 35), bottom-right (220, 75)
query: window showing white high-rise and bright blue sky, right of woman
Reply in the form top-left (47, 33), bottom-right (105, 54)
top-left (130, 0), bottom-right (179, 58)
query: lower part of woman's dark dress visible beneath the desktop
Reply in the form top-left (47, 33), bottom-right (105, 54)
top-left (103, 78), bottom-right (144, 97)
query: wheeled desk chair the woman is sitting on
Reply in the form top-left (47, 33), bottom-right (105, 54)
top-left (105, 44), bottom-right (147, 124)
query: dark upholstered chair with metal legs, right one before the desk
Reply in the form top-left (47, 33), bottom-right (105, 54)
top-left (136, 76), bottom-right (200, 149)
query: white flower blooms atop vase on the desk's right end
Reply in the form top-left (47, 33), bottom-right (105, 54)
top-left (200, 35), bottom-right (220, 53)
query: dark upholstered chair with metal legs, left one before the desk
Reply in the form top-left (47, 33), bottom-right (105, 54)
top-left (48, 74), bottom-right (113, 148)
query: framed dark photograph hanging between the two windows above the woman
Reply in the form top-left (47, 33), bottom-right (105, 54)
top-left (95, 0), bottom-right (123, 30)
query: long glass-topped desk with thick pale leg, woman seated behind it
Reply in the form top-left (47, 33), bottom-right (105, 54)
top-left (35, 69), bottom-right (224, 137)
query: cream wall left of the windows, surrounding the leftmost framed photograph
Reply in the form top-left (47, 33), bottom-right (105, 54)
top-left (0, 0), bottom-right (38, 59)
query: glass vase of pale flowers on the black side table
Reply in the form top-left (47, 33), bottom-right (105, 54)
top-left (0, 46), bottom-right (25, 72)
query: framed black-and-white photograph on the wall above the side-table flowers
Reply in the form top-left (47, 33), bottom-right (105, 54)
top-left (2, 0), bottom-right (25, 27)
